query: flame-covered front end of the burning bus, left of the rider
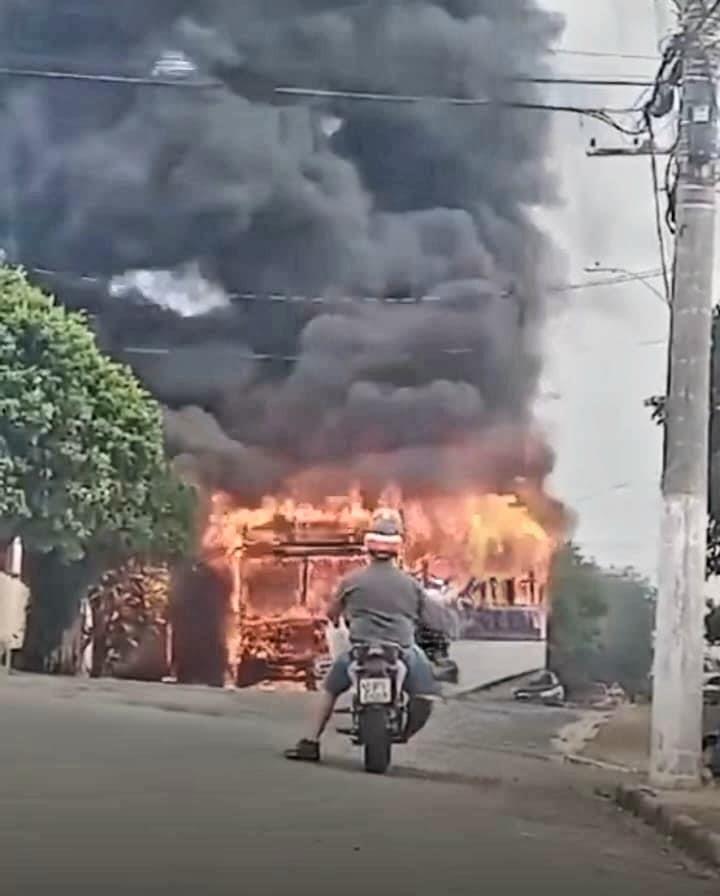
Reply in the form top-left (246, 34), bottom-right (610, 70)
top-left (203, 494), bottom-right (370, 689)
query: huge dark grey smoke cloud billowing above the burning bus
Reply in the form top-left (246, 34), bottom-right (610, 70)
top-left (0, 0), bottom-right (562, 498)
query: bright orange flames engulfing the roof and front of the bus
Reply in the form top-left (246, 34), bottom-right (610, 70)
top-left (203, 488), bottom-right (562, 684)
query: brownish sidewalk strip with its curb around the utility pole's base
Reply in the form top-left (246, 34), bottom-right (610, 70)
top-left (582, 705), bottom-right (720, 859)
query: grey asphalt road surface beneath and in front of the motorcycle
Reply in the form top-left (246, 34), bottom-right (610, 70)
top-left (0, 685), bottom-right (718, 896)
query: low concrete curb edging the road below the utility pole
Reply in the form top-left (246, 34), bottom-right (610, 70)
top-left (615, 784), bottom-right (720, 868)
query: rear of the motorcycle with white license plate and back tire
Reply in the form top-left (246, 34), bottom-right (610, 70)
top-left (342, 643), bottom-right (410, 775)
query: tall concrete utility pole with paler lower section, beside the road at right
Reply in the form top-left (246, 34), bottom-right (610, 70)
top-left (650, 0), bottom-right (720, 787)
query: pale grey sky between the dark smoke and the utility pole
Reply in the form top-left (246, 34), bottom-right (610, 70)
top-left (538, 0), bottom-right (668, 580)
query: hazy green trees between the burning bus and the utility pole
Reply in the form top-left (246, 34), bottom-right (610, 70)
top-left (549, 544), bottom-right (654, 691)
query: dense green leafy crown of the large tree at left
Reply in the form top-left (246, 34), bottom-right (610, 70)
top-left (0, 268), bottom-right (194, 562)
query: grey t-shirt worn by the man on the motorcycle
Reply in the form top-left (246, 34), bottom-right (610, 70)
top-left (337, 560), bottom-right (446, 647)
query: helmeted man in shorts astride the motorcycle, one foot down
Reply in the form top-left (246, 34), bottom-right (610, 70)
top-left (285, 511), bottom-right (450, 762)
